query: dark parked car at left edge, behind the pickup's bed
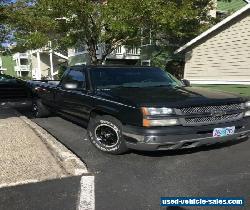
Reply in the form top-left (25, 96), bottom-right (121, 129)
top-left (0, 74), bottom-right (30, 100)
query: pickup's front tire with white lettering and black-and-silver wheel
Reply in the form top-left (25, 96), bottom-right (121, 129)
top-left (87, 115), bottom-right (128, 155)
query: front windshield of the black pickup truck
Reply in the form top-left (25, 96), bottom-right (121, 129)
top-left (90, 67), bottom-right (183, 89)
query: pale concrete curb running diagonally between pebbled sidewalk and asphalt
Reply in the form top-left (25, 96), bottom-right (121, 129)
top-left (19, 114), bottom-right (89, 176)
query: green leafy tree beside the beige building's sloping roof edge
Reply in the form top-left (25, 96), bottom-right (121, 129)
top-left (142, 0), bottom-right (215, 68)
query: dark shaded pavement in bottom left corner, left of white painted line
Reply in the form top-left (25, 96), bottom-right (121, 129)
top-left (0, 177), bottom-right (80, 210)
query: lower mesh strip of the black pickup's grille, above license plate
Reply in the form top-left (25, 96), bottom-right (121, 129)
top-left (185, 113), bottom-right (243, 125)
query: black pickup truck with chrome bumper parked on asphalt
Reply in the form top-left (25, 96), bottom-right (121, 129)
top-left (30, 66), bottom-right (250, 154)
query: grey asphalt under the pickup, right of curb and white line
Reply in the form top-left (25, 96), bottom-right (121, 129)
top-left (18, 106), bottom-right (250, 210)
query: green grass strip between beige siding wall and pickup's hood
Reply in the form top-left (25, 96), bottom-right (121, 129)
top-left (193, 85), bottom-right (250, 96)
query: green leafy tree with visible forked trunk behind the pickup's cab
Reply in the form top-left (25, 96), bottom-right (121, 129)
top-left (9, 0), bottom-right (140, 64)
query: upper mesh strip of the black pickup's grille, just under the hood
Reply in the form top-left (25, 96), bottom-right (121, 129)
top-left (181, 104), bottom-right (242, 114)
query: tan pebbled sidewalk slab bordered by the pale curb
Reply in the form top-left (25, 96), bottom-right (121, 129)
top-left (0, 109), bottom-right (67, 186)
